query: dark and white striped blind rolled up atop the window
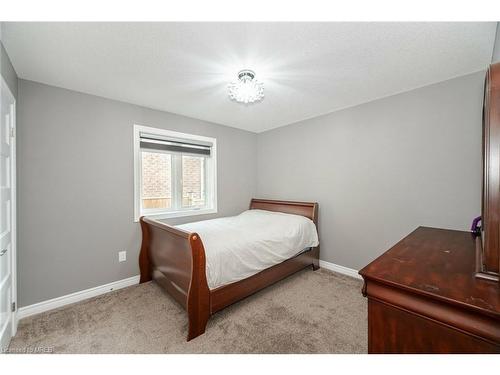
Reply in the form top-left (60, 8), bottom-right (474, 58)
top-left (140, 133), bottom-right (212, 156)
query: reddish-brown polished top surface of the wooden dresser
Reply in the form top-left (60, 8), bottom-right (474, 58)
top-left (359, 227), bottom-right (500, 318)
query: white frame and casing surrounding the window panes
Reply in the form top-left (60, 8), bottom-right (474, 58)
top-left (134, 124), bottom-right (217, 222)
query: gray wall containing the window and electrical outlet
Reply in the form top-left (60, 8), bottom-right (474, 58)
top-left (17, 80), bottom-right (256, 306)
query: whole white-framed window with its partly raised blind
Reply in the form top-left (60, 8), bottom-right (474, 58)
top-left (134, 125), bottom-right (217, 221)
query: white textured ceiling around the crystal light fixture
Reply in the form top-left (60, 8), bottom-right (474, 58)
top-left (3, 22), bottom-right (496, 132)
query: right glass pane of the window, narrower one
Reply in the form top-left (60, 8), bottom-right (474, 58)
top-left (182, 155), bottom-right (206, 207)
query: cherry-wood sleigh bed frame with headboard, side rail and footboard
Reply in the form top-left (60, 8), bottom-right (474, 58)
top-left (139, 199), bottom-right (319, 341)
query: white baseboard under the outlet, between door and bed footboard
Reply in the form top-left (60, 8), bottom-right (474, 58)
top-left (17, 275), bottom-right (139, 320)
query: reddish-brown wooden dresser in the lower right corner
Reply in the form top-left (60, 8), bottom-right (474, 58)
top-left (359, 227), bottom-right (500, 353)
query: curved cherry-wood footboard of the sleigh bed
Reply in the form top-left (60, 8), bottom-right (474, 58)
top-left (139, 217), bottom-right (210, 341)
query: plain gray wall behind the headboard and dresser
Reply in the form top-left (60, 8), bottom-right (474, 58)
top-left (257, 72), bottom-right (484, 269)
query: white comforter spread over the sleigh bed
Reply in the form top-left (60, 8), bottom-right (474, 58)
top-left (177, 210), bottom-right (318, 289)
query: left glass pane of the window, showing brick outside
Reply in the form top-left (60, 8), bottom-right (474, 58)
top-left (141, 151), bottom-right (172, 209)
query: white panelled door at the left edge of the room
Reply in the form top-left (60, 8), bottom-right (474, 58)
top-left (0, 77), bottom-right (16, 351)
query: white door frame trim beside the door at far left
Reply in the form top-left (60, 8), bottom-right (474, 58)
top-left (0, 75), bottom-right (19, 337)
